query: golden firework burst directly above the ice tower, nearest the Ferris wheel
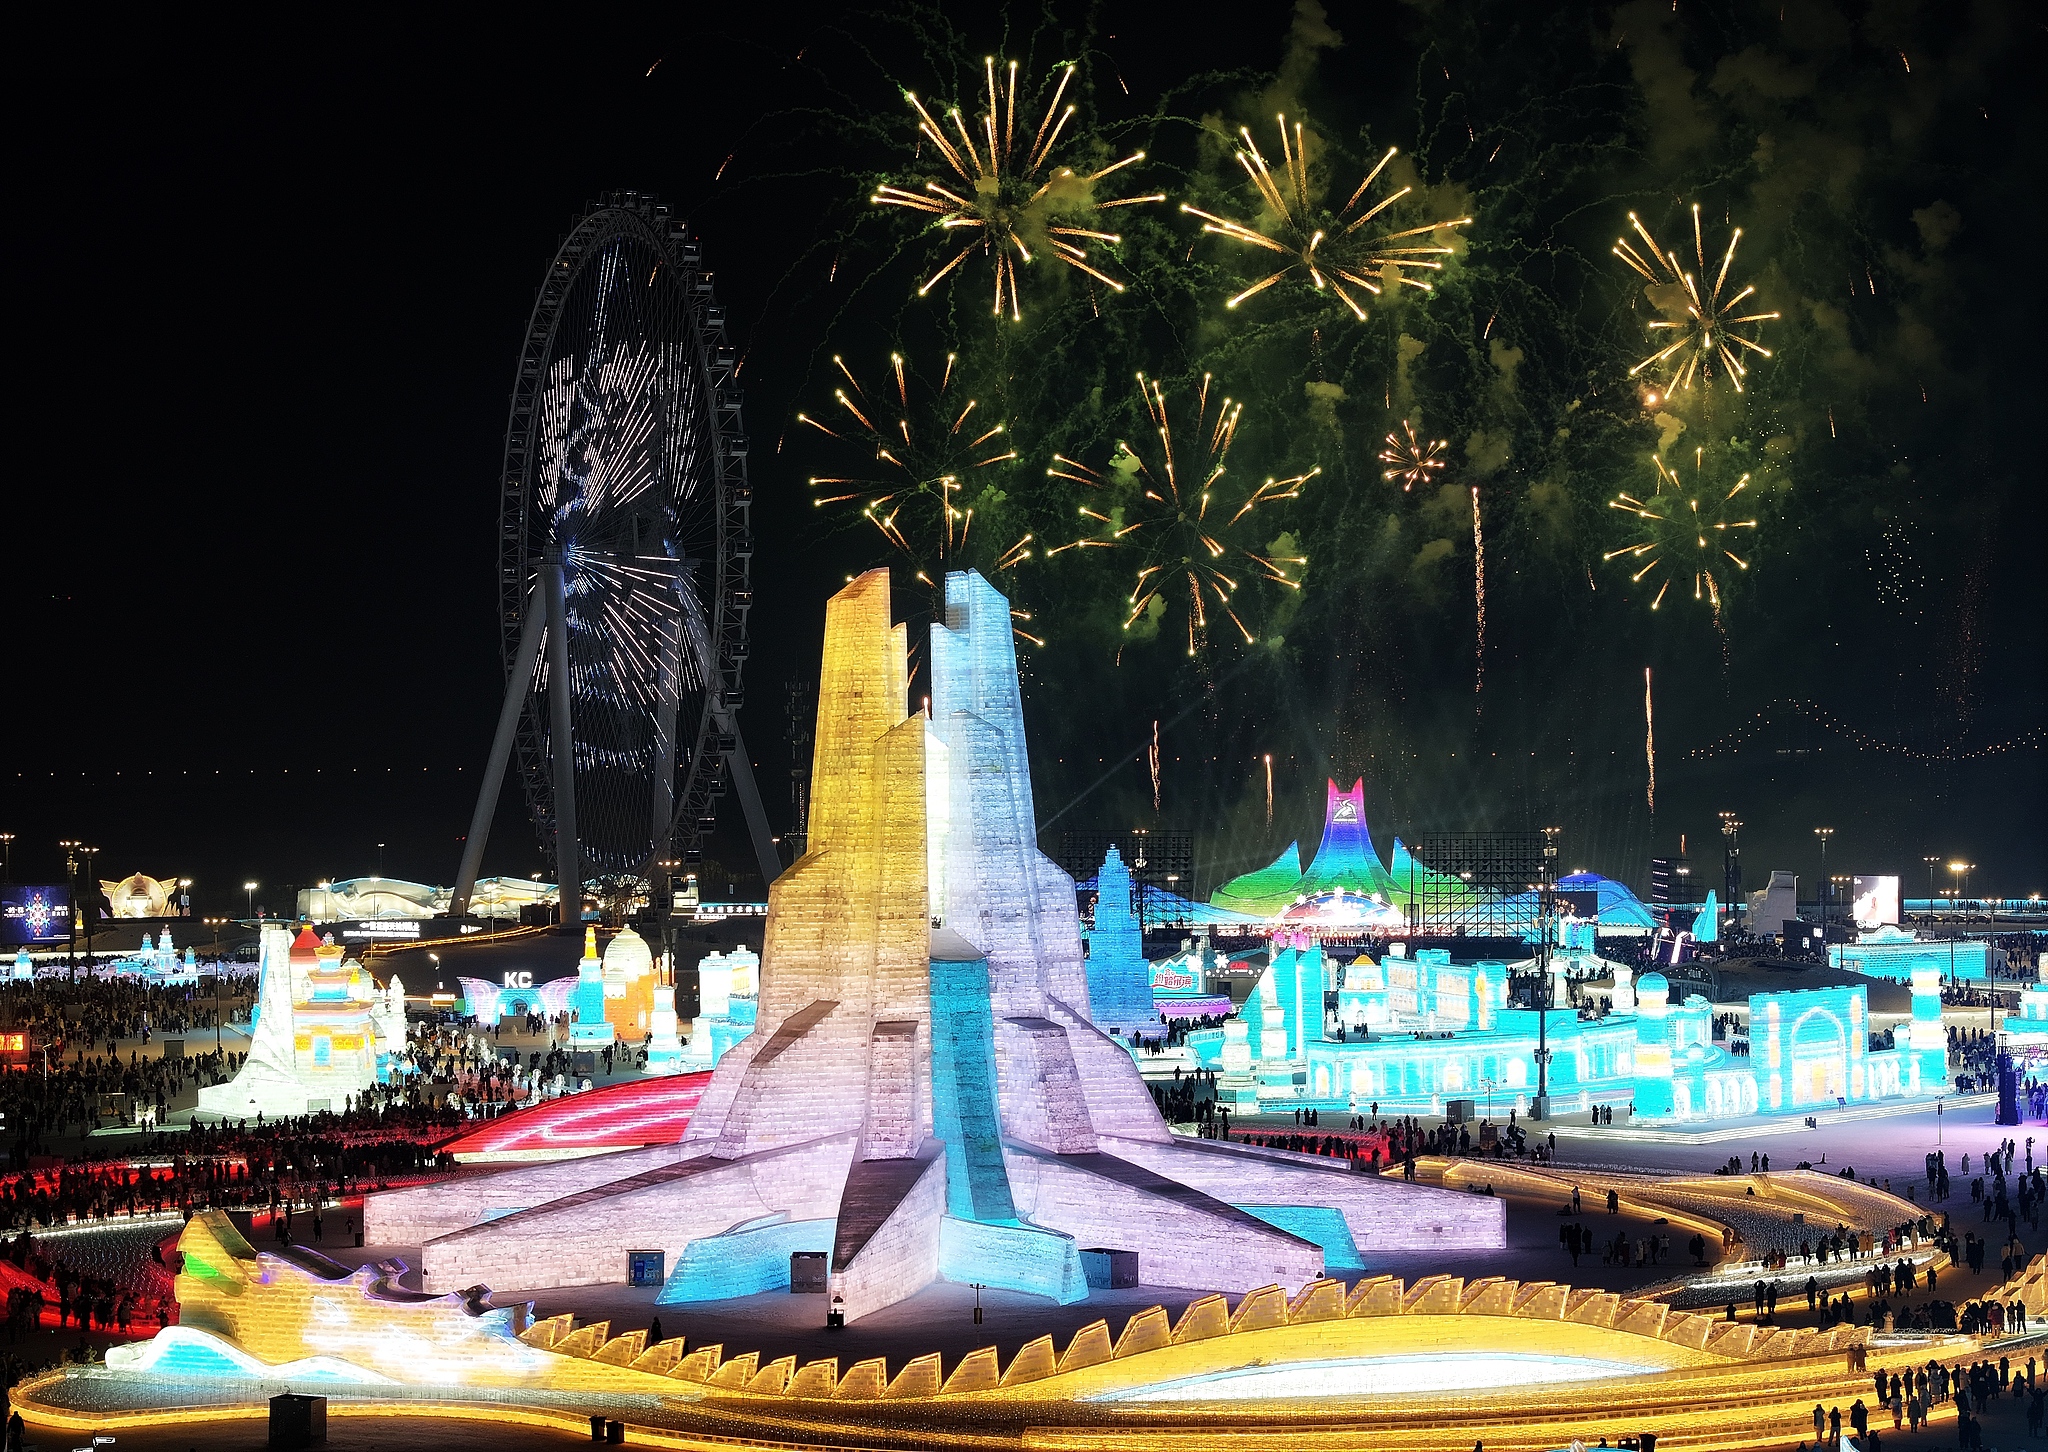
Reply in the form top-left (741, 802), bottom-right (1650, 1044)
top-left (797, 352), bottom-right (1030, 588)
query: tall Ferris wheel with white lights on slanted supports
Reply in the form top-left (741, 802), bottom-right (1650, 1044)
top-left (453, 193), bottom-right (780, 922)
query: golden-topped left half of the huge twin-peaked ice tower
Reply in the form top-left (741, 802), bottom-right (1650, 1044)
top-left (391, 571), bottom-right (944, 1319)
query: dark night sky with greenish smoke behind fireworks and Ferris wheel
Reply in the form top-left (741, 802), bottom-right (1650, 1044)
top-left (0, 0), bottom-right (2048, 911)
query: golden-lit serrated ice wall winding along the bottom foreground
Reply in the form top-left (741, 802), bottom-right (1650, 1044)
top-left (36, 1212), bottom-right (1949, 1452)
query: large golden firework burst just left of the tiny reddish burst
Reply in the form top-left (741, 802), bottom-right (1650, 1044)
top-left (1047, 373), bottom-right (1323, 655)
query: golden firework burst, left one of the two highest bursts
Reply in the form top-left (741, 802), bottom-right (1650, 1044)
top-left (868, 55), bottom-right (1165, 322)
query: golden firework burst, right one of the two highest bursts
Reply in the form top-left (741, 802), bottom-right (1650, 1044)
top-left (1182, 117), bottom-right (1473, 322)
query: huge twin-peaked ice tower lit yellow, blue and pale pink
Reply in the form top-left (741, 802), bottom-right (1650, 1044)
top-left (365, 571), bottom-right (1505, 1319)
